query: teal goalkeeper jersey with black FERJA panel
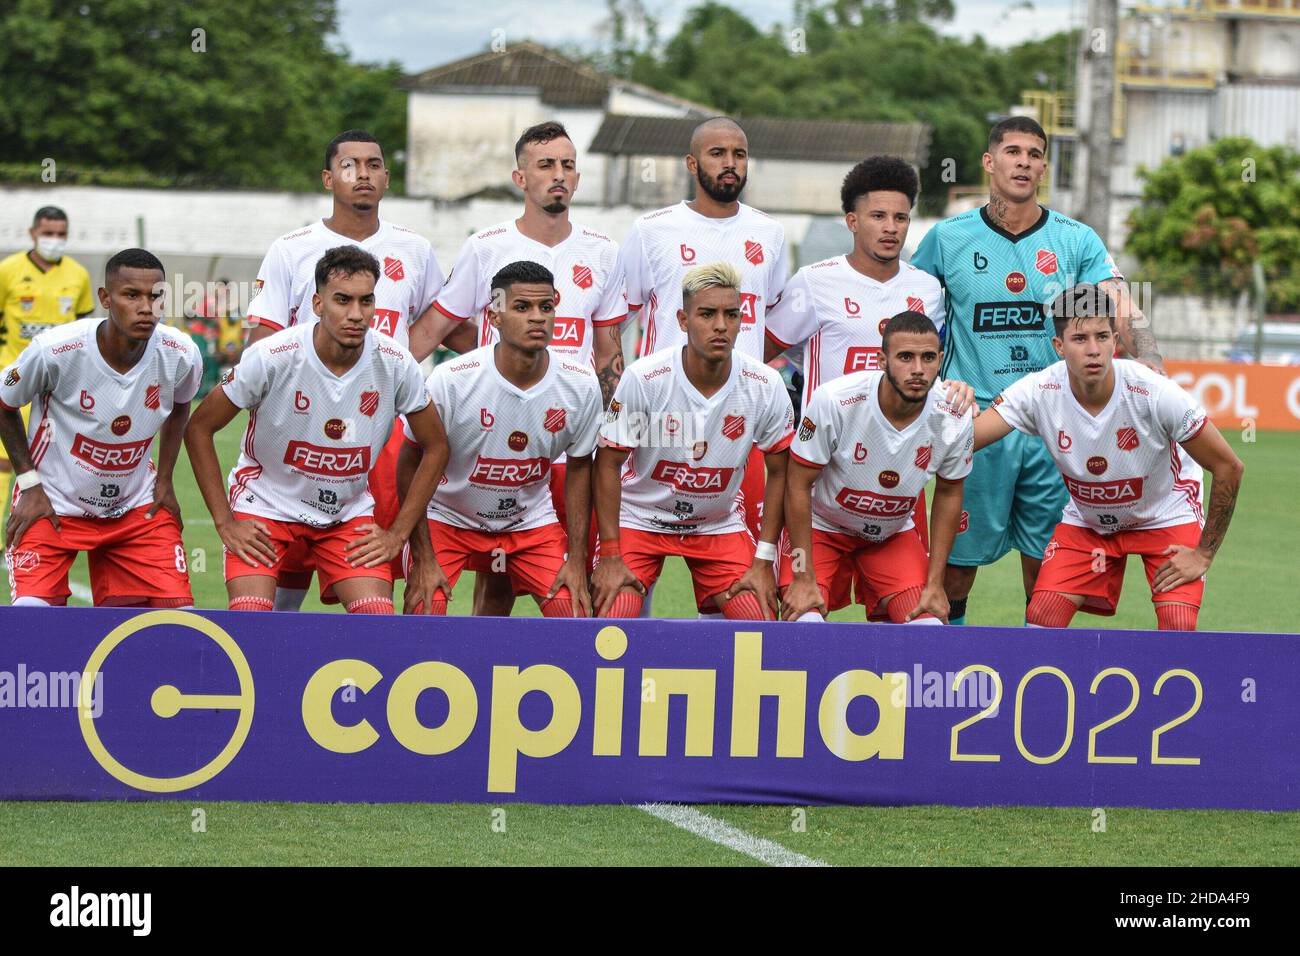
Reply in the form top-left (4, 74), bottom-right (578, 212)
top-left (911, 207), bottom-right (1121, 407)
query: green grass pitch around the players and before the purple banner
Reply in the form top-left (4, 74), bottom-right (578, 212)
top-left (0, 421), bottom-right (1300, 866)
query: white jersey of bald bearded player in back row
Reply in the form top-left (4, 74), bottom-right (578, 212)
top-left (620, 202), bottom-right (789, 360)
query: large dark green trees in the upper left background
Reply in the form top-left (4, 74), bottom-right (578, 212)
top-left (0, 0), bottom-right (406, 189)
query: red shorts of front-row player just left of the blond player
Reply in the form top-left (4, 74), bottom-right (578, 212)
top-left (429, 519), bottom-right (568, 601)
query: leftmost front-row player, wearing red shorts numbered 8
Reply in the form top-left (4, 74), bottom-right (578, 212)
top-left (0, 248), bottom-right (203, 607)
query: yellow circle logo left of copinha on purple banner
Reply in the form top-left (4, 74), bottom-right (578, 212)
top-left (77, 611), bottom-right (254, 793)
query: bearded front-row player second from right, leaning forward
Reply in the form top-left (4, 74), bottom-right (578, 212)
top-left (781, 312), bottom-right (975, 623)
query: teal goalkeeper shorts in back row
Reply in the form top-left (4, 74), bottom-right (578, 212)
top-left (948, 432), bottom-right (1070, 567)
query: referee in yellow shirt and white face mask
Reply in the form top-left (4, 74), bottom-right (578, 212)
top-left (0, 206), bottom-right (95, 515)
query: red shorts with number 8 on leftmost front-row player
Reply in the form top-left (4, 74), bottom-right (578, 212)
top-left (7, 505), bottom-right (194, 607)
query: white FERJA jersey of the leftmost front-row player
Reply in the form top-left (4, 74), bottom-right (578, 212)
top-left (0, 319), bottom-right (203, 518)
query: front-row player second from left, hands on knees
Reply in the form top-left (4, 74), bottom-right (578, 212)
top-left (185, 246), bottom-right (447, 614)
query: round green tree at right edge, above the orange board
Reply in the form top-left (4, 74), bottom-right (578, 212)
top-left (1127, 138), bottom-right (1300, 312)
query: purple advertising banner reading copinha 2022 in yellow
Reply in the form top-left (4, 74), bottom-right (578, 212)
top-left (0, 607), bottom-right (1300, 810)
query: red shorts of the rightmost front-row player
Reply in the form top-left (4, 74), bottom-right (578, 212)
top-left (1034, 522), bottom-right (1205, 617)
